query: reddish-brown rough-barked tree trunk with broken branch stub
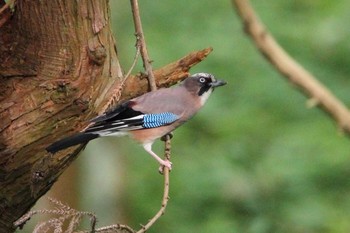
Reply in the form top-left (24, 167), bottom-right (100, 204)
top-left (0, 0), bottom-right (211, 232)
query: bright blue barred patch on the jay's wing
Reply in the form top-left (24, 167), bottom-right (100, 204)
top-left (142, 112), bottom-right (179, 128)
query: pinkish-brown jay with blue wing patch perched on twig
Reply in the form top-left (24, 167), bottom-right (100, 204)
top-left (46, 73), bottom-right (226, 170)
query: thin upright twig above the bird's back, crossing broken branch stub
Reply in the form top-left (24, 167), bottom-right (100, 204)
top-left (130, 0), bottom-right (157, 91)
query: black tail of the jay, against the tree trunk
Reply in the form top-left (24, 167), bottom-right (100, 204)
top-left (46, 133), bottom-right (99, 154)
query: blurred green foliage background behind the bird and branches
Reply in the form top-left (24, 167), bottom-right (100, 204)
top-left (28, 0), bottom-right (350, 233)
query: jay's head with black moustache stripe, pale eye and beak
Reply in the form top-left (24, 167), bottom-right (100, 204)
top-left (182, 73), bottom-right (226, 105)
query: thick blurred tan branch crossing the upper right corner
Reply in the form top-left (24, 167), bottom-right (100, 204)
top-left (232, 0), bottom-right (350, 135)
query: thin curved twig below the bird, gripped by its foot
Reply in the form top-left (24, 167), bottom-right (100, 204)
top-left (137, 134), bottom-right (171, 233)
